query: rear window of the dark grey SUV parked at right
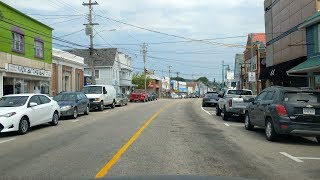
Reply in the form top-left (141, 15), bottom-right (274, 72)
top-left (283, 92), bottom-right (320, 103)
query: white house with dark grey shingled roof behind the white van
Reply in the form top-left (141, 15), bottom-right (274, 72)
top-left (68, 48), bottom-right (121, 93)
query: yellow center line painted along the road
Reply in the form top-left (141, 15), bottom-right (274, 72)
top-left (95, 103), bottom-right (173, 178)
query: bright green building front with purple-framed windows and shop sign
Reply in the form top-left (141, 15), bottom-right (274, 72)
top-left (0, 1), bottom-right (53, 97)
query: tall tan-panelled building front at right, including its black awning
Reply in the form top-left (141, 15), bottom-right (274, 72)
top-left (260, 0), bottom-right (312, 87)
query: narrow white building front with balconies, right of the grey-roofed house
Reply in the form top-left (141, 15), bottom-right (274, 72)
top-left (118, 52), bottom-right (134, 95)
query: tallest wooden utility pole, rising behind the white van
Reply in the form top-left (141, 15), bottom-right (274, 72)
top-left (82, 0), bottom-right (99, 84)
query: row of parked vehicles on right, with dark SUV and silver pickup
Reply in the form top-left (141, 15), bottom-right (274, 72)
top-left (210, 86), bottom-right (320, 143)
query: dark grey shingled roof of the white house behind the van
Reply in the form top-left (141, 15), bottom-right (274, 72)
top-left (66, 48), bottom-right (118, 66)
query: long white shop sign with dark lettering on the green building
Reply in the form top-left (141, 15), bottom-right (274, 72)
top-left (7, 64), bottom-right (51, 77)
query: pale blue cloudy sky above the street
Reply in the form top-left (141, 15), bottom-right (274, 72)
top-left (3, 0), bottom-right (265, 81)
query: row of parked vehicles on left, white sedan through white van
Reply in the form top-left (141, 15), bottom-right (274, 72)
top-left (0, 85), bottom-right (132, 134)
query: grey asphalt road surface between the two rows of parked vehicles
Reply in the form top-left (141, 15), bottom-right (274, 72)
top-left (0, 99), bottom-right (320, 179)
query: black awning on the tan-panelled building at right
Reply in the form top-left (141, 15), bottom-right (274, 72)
top-left (259, 57), bottom-right (306, 80)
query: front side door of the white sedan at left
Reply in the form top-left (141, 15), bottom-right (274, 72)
top-left (28, 95), bottom-right (45, 126)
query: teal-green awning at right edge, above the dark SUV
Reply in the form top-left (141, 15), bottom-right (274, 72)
top-left (287, 56), bottom-right (320, 76)
